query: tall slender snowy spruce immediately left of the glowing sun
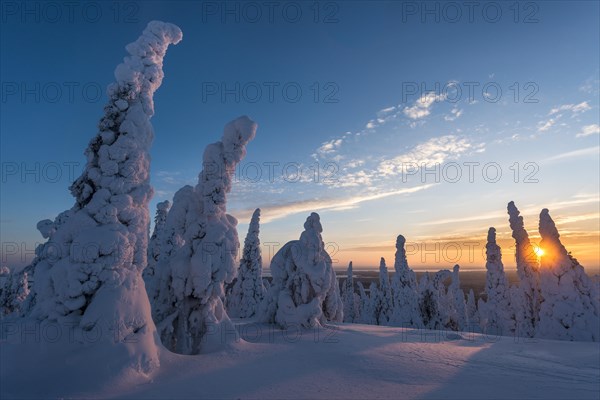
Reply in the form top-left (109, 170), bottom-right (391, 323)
top-left (507, 201), bottom-right (541, 337)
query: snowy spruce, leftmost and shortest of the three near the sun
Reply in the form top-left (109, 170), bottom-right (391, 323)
top-left (479, 228), bottom-right (515, 336)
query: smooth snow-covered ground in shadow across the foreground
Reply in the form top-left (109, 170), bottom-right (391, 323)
top-left (0, 321), bottom-right (600, 399)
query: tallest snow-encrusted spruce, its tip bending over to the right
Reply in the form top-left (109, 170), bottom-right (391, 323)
top-left (20, 21), bottom-right (182, 373)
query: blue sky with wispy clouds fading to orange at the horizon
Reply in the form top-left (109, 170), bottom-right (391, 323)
top-left (0, 1), bottom-right (600, 269)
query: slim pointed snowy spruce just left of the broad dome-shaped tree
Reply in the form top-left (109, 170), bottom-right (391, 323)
top-left (226, 208), bottom-right (265, 318)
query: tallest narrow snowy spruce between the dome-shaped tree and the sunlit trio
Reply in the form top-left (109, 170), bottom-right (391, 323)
top-left (391, 235), bottom-right (423, 328)
